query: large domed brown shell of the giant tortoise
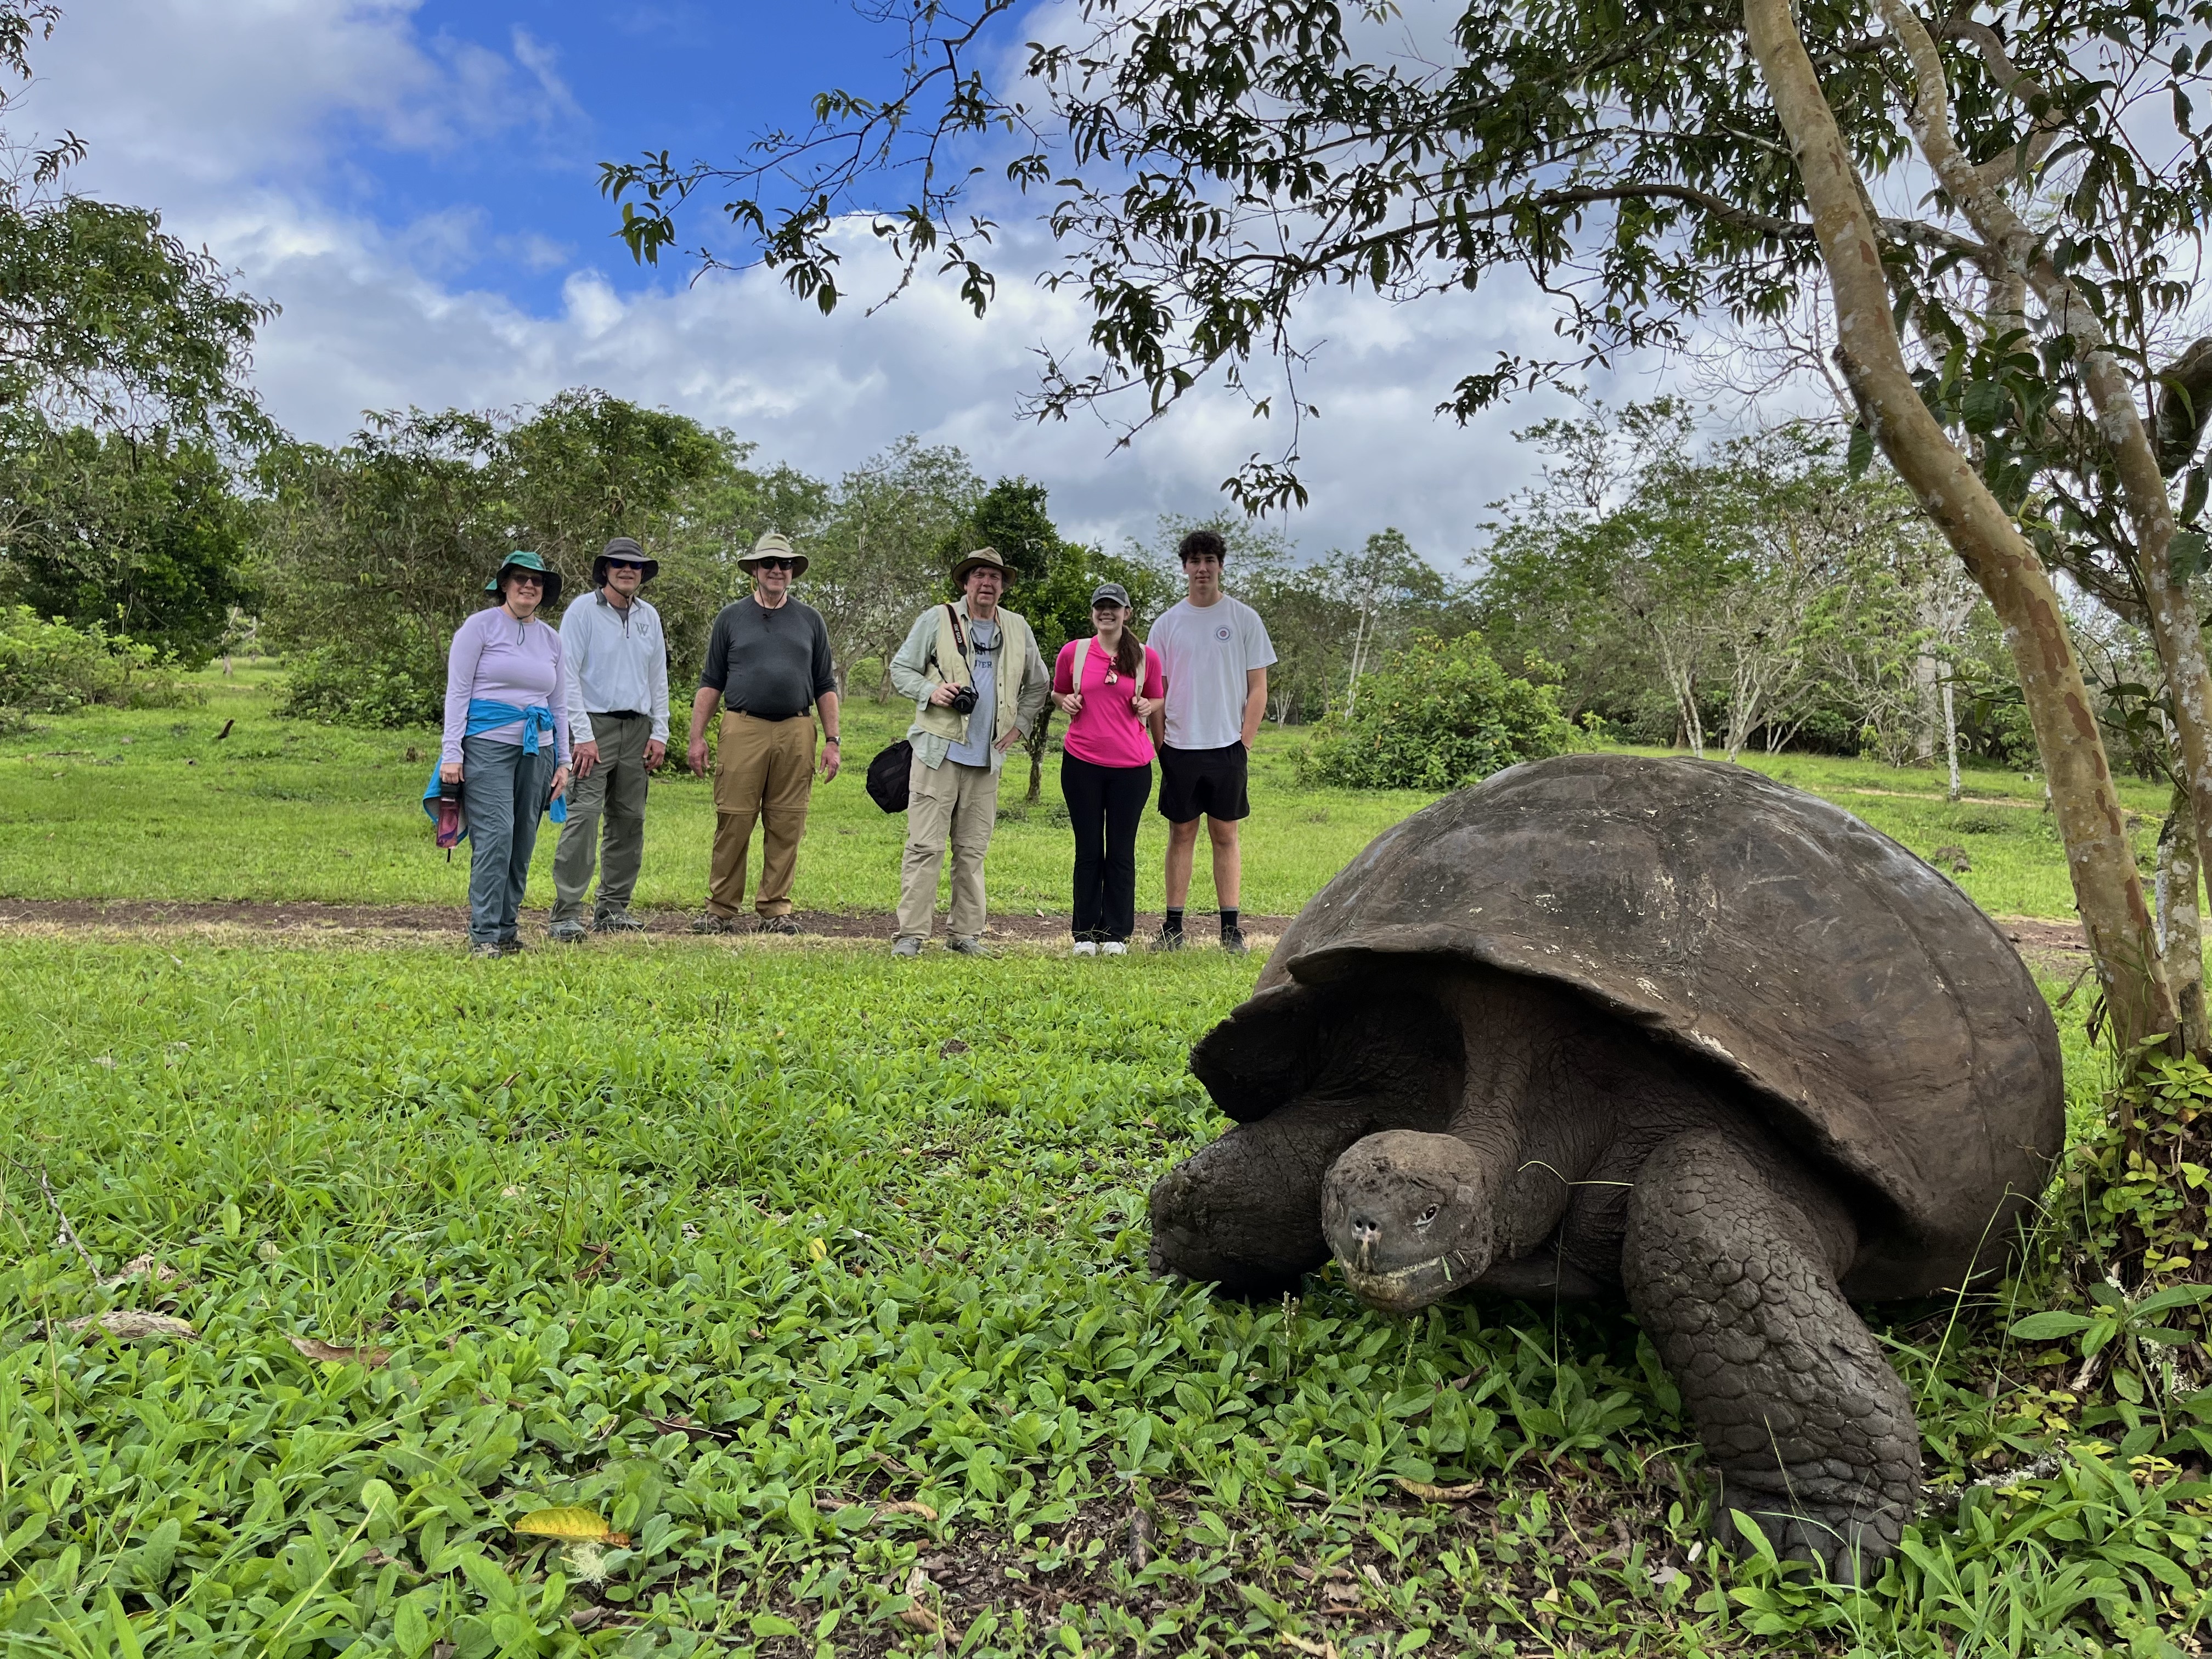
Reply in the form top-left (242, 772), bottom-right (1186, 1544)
top-left (1192, 754), bottom-right (2066, 1299)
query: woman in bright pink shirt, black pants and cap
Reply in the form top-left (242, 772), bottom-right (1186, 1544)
top-left (1053, 582), bottom-right (1168, 956)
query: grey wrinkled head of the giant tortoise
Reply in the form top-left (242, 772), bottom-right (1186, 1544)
top-left (1321, 1128), bottom-right (1496, 1314)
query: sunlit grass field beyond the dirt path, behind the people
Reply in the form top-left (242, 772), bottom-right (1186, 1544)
top-left (0, 670), bottom-right (2163, 916)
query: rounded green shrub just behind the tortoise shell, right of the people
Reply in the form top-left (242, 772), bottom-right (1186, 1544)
top-left (1299, 633), bottom-right (1577, 789)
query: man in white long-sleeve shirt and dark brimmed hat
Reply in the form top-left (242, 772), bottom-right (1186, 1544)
top-left (546, 535), bottom-right (668, 943)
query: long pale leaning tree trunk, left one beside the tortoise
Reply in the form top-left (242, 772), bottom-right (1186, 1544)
top-left (1743, 0), bottom-right (2179, 1053)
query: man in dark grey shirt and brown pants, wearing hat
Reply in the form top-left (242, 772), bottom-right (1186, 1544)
top-left (690, 531), bottom-right (838, 934)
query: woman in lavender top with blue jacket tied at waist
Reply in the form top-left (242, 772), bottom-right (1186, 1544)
top-left (438, 553), bottom-right (568, 956)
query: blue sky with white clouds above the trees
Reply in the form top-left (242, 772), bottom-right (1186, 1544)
top-left (18, 0), bottom-right (1610, 568)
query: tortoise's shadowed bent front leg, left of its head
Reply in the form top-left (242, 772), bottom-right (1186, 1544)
top-left (1150, 1102), bottom-right (1376, 1296)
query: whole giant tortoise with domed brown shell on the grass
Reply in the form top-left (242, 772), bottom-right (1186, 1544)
top-left (1153, 754), bottom-right (2064, 1575)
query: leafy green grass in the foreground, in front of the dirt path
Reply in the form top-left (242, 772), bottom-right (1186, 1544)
top-left (0, 942), bottom-right (2212, 1659)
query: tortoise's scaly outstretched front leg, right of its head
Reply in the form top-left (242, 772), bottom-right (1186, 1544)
top-left (1621, 1130), bottom-right (1920, 1582)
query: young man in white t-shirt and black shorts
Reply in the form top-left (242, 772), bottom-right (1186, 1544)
top-left (1144, 531), bottom-right (1274, 951)
